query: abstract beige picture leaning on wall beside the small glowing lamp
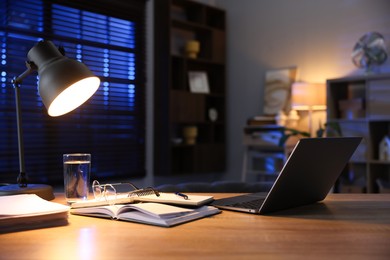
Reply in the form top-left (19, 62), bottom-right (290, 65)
top-left (263, 67), bottom-right (297, 115)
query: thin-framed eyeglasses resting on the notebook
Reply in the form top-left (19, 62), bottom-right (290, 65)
top-left (92, 180), bottom-right (160, 205)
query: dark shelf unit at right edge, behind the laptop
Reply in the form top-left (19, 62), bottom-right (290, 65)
top-left (327, 74), bottom-right (390, 193)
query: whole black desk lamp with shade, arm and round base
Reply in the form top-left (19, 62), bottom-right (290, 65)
top-left (0, 41), bottom-right (100, 200)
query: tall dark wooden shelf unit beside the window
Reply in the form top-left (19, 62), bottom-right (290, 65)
top-left (154, 0), bottom-right (226, 175)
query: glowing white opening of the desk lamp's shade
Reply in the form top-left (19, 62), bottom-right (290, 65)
top-left (48, 77), bottom-right (100, 116)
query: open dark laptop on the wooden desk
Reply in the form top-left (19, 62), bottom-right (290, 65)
top-left (211, 137), bottom-right (362, 215)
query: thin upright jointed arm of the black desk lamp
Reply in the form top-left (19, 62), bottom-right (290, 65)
top-left (12, 61), bottom-right (37, 187)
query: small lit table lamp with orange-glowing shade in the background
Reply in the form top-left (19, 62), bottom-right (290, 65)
top-left (291, 82), bottom-right (326, 136)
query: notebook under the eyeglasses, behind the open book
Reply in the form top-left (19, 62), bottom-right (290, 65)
top-left (71, 192), bottom-right (214, 208)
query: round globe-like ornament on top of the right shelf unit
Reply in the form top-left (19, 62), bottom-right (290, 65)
top-left (352, 32), bottom-right (387, 72)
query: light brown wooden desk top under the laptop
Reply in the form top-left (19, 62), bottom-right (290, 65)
top-left (0, 194), bottom-right (390, 260)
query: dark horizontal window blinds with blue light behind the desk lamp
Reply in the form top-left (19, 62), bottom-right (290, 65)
top-left (0, 0), bottom-right (145, 184)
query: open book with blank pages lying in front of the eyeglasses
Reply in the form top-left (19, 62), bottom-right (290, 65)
top-left (70, 202), bottom-right (220, 227)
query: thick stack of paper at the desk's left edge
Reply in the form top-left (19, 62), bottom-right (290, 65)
top-left (0, 194), bottom-right (69, 233)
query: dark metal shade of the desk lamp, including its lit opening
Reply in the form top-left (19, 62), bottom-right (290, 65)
top-left (27, 41), bottom-right (100, 116)
